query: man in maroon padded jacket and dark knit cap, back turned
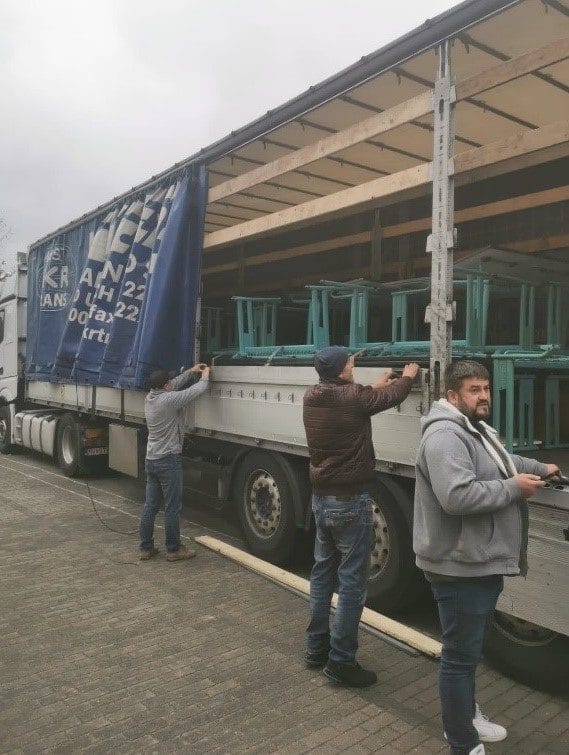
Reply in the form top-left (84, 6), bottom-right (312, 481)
top-left (303, 346), bottom-right (419, 687)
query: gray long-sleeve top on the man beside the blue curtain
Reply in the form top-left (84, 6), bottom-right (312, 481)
top-left (144, 370), bottom-right (209, 460)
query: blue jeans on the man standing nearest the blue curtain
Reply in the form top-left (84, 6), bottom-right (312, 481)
top-left (140, 454), bottom-right (182, 552)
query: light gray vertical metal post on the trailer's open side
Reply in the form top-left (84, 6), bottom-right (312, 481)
top-left (425, 40), bottom-right (456, 402)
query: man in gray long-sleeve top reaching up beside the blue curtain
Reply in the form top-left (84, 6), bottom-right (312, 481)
top-left (140, 364), bottom-right (209, 561)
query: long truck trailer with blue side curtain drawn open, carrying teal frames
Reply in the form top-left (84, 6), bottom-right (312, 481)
top-left (0, 0), bottom-right (569, 685)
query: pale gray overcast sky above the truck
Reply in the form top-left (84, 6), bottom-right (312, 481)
top-left (0, 0), bottom-right (456, 258)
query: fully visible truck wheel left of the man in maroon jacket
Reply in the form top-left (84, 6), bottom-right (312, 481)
top-left (234, 451), bottom-right (296, 564)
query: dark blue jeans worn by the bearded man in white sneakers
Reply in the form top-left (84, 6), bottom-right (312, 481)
top-left (431, 575), bottom-right (504, 755)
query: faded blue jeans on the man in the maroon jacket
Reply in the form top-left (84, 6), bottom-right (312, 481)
top-left (307, 494), bottom-right (373, 663)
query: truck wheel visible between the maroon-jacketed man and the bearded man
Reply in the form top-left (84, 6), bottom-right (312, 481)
top-left (367, 481), bottom-right (419, 611)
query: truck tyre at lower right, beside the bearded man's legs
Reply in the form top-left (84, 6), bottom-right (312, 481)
top-left (484, 611), bottom-right (569, 693)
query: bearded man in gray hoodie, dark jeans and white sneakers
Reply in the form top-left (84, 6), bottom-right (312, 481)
top-left (413, 360), bottom-right (560, 755)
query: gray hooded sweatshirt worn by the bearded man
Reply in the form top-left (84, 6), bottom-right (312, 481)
top-left (413, 399), bottom-right (547, 578)
